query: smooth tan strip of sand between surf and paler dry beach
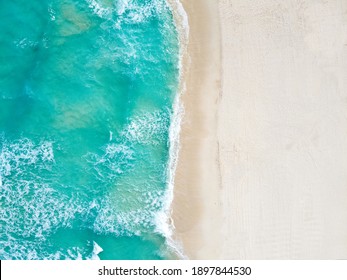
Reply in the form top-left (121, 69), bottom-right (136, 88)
top-left (171, 0), bottom-right (222, 259)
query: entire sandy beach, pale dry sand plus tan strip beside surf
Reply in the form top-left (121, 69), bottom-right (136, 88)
top-left (173, 0), bottom-right (347, 259)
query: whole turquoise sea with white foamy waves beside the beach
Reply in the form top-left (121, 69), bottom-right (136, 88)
top-left (0, 0), bottom-right (179, 259)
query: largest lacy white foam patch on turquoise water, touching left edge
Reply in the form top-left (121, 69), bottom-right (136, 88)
top-left (0, 138), bottom-right (86, 245)
